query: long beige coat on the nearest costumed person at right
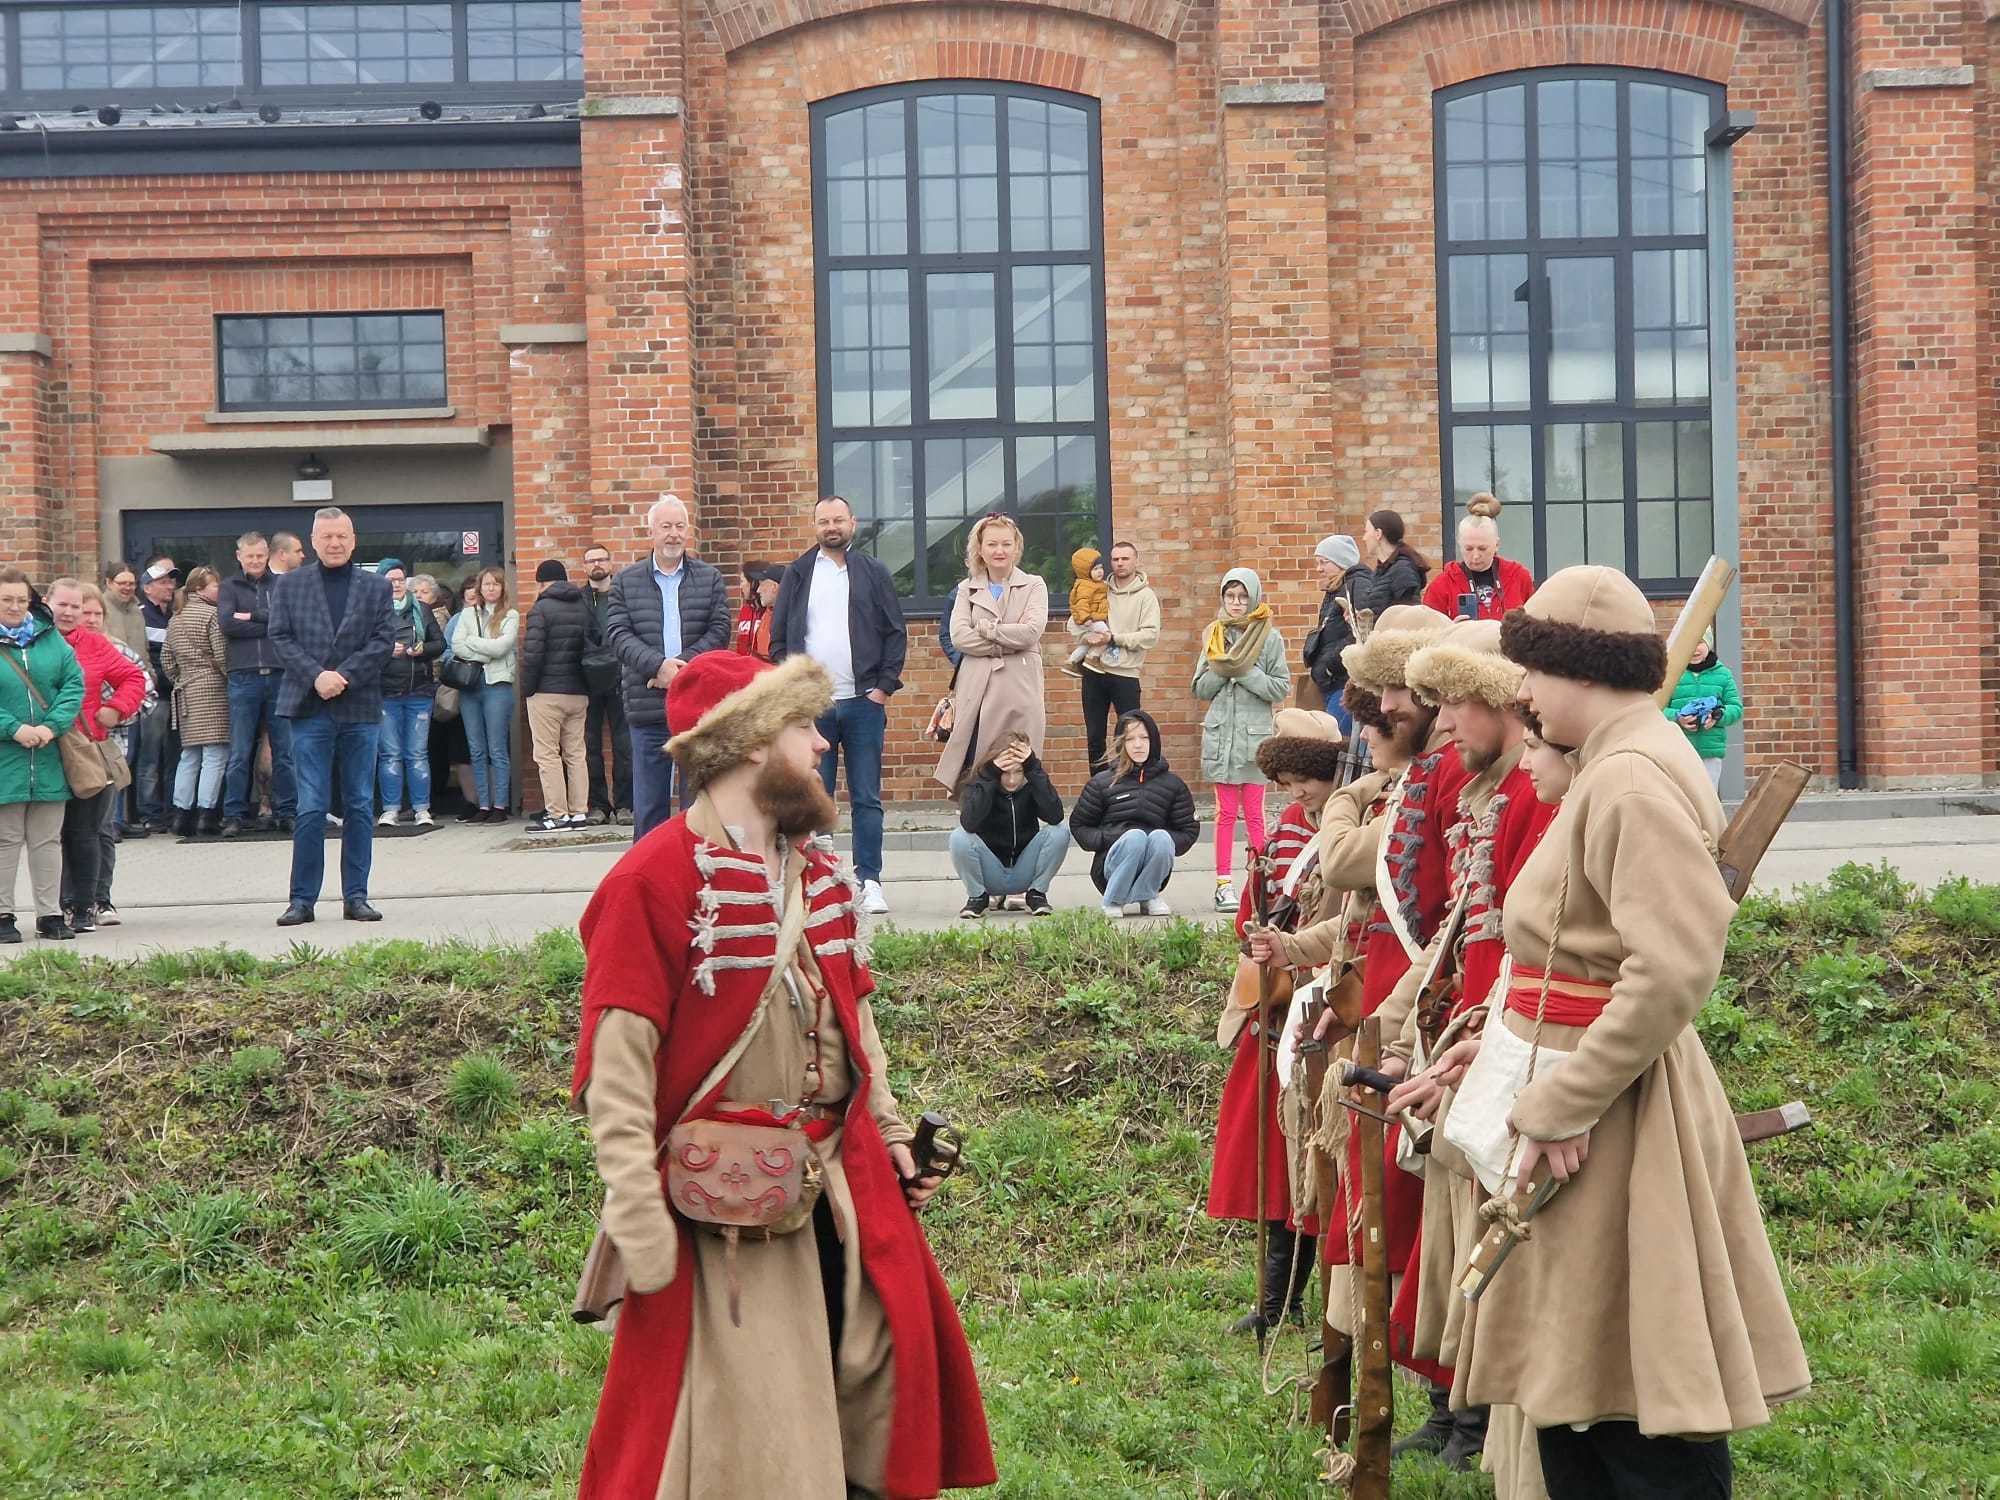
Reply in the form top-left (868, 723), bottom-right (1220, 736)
top-left (1452, 700), bottom-right (1812, 1436)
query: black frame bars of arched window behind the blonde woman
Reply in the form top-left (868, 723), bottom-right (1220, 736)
top-left (810, 78), bottom-right (1112, 618)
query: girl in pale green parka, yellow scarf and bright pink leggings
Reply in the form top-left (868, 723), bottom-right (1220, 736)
top-left (1194, 568), bottom-right (1292, 912)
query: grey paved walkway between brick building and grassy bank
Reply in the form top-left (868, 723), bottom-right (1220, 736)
top-left (14, 814), bottom-right (2000, 958)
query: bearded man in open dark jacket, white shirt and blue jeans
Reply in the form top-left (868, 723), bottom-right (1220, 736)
top-left (770, 494), bottom-right (910, 916)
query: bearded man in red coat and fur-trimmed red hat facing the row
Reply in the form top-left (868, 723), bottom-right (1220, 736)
top-left (574, 652), bottom-right (996, 1500)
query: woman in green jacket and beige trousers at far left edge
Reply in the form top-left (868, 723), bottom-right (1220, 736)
top-left (0, 568), bottom-right (84, 942)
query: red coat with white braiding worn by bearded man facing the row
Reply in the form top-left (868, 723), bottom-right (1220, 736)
top-left (572, 814), bottom-right (996, 1500)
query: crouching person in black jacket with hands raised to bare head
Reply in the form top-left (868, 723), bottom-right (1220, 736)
top-left (952, 734), bottom-right (1070, 918)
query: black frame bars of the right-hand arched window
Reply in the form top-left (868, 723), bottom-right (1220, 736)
top-left (1432, 66), bottom-right (1734, 598)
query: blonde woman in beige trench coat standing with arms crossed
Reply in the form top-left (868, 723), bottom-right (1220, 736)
top-left (932, 516), bottom-right (1048, 794)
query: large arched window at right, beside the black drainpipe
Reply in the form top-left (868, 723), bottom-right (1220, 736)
top-left (1436, 68), bottom-right (1722, 592)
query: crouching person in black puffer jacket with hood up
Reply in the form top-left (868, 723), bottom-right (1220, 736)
top-left (1070, 710), bottom-right (1202, 916)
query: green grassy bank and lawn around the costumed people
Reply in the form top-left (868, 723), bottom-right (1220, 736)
top-left (0, 866), bottom-right (2000, 1500)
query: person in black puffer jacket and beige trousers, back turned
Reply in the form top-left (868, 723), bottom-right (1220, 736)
top-left (520, 558), bottom-right (602, 834)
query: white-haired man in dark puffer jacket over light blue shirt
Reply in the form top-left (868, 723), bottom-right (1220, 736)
top-left (604, 494), bottom-right (730, 840)
